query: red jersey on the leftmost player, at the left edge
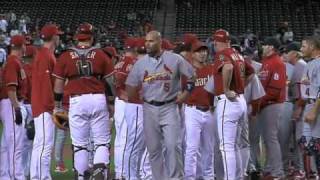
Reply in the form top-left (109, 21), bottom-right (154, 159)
top-left (3, 55), bottom-right (27, 100)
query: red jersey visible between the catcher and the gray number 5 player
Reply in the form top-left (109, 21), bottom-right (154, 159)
top-left (114, 56), bottom-right (142, 104)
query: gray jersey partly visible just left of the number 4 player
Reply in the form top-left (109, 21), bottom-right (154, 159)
top-left (289, 59), bottom-right (307, 99)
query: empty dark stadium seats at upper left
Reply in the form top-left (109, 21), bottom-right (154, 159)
top-left (0, 0), bottom-right (157, 37)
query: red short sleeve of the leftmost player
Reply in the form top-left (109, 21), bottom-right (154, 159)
top-left (4, 60), bottom-right (20, 86)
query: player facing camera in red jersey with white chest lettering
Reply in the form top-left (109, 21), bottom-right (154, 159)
top-left (184, 41), bottom-right (214, 179)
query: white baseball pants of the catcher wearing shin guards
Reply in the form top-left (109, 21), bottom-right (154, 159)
top-left (69, 94), bottom-right (111, 179)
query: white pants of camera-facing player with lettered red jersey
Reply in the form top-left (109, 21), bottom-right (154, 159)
top-left (184, 105), bottom-right (214, 179)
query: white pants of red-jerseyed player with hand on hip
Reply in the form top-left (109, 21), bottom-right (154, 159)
top-left (216, 95), bottom-right (247, 180)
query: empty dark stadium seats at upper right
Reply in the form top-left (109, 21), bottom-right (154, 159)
top-left (176, 0), bottom-right (320, 39)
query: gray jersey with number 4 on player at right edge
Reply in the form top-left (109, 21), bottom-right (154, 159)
top-left (301, 58), bottom-right (320, 99)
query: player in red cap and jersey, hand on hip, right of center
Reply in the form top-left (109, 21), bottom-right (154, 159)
top-left (213, 29), bottom-right (254, 180)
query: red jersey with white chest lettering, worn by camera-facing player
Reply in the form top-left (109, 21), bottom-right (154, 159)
top-left (186, 65), bottom-right (213, 107)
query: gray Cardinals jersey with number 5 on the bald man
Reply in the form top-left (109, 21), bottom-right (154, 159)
top-left (126, 51), bottom-right (194, 102)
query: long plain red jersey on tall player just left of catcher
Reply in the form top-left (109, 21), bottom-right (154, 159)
top-left (31, 47), bottom-right (56, 117)
